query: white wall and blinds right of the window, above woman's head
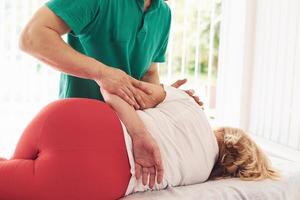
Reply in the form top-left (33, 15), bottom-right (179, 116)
top-left (217, 0), bottom-right (300, 150)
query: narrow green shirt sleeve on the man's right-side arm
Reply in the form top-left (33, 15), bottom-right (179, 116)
top-left (153, 10), bottom-right (171, 63)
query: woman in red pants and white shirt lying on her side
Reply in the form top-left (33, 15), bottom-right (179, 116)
top-left (0, 83), bottom-right (276, 200)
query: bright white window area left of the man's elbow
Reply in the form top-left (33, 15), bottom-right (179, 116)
top-left (0, 0), bottom-right (59, 158)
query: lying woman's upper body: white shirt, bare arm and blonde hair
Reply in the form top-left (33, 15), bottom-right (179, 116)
top-left (102, 80), bottom-right (278, 194)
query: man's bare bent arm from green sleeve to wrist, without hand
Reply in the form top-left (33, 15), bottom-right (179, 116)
top-left (19, 6), bottom-right (105, 83)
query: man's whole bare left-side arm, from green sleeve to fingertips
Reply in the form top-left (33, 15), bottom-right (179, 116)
top-left (20, 6), bottom-right (151, 107)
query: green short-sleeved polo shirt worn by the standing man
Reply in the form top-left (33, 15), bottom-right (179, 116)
top-left (46, 0), bottom-right (171, 100)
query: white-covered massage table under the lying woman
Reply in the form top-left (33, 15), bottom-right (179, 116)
top-left (122, 155), bottom-right (300, 200)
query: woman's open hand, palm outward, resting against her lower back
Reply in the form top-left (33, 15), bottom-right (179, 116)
top-left (132, 131), bottom-right (164, 189)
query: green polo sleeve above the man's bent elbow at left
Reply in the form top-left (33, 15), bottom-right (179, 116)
top-left (46, 0), bottom-right (101, 35)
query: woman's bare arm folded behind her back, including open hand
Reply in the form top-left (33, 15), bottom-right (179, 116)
top-left (101, 83), bottom-right (166, 188)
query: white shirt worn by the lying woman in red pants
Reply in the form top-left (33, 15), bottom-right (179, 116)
top-left (121, 85), bottom-right (218, 195)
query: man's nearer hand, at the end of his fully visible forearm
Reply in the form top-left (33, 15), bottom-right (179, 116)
top-left (96, 67), bottom-right (152, 109)
